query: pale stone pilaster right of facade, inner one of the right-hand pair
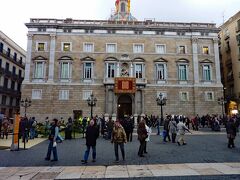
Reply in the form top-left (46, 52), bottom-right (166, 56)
top-left (192, 37), bottom-right (199, 84)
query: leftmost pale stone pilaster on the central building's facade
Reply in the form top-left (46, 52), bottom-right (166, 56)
top-left (24, 34), bottom-right (33, 82)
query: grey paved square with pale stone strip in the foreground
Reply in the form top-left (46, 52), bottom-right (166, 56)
top-left (0, 129), bottom-right (240, 179)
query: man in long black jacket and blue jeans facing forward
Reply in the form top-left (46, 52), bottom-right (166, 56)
top-left (82, 120), bottom-right (99, 164)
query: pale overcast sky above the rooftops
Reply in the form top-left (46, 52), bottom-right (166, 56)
top-left (0, 0), bottom-right (240, 49)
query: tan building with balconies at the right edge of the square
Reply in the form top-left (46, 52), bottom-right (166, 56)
top-left (219, 11), bottom-right (240, 113)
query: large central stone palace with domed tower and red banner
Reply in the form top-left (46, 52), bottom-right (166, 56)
top-left (22, 0), bottom-right (223, 120)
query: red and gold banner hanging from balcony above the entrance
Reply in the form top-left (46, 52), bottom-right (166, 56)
top-left (114, 77), bottom-right (136, 93)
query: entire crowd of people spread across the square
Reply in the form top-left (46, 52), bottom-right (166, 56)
top-left (0, 114), bottom-right (240, 164)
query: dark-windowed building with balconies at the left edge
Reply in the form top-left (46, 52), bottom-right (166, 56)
top-left (0, 31), bottom-right (26, 117)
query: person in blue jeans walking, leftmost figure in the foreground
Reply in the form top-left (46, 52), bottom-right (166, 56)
top-left (45, 119), bottom-right (59, 161)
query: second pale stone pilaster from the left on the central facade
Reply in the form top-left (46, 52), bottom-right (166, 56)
top-left (48, 34), bottom-right (56, 83)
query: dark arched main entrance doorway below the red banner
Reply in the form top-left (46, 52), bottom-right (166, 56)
top-left (117, 95), bottom-right (132, 119)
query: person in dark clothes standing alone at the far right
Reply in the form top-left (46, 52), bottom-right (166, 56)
top-left (226, 118), bottom-right (237, 148)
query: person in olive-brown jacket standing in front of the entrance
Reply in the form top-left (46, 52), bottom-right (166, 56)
top-left (111, 120), bottom-right (127, 162)
